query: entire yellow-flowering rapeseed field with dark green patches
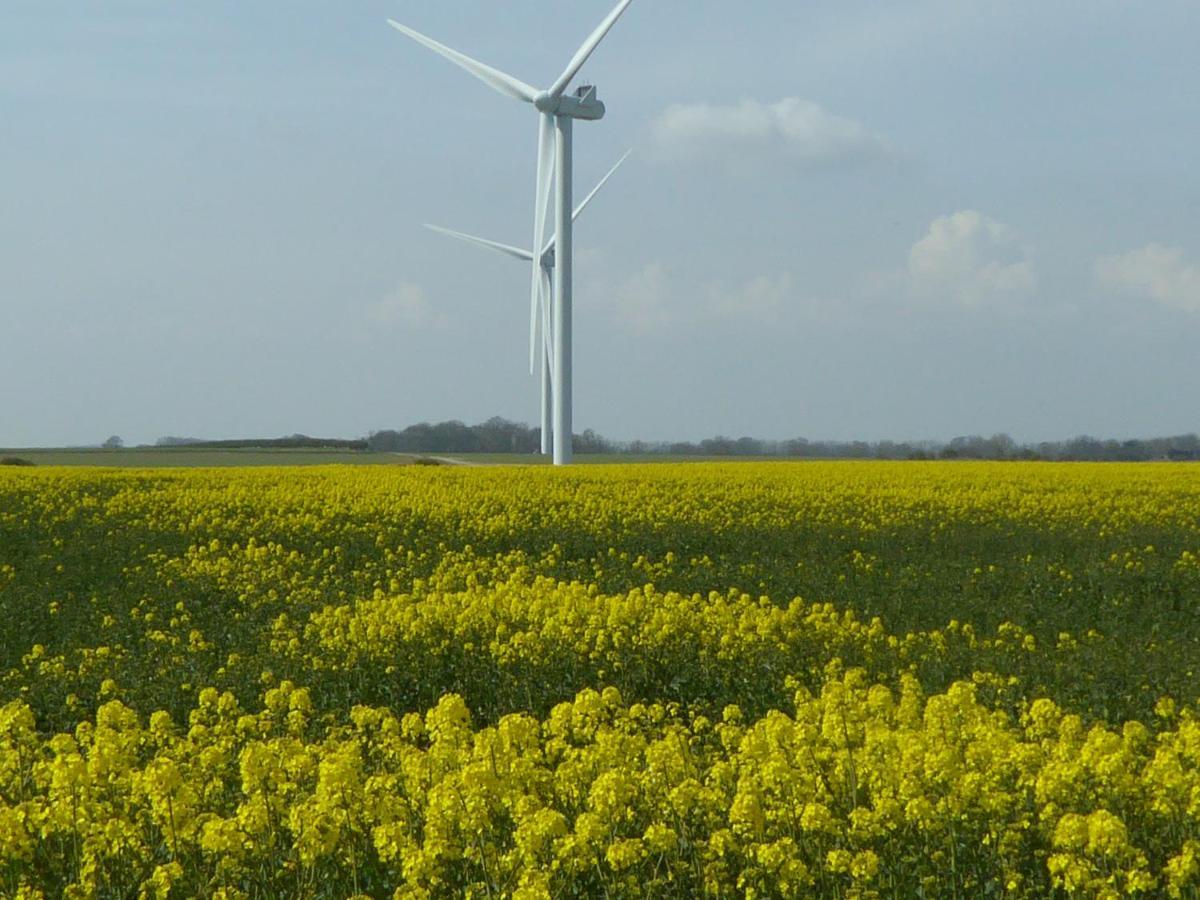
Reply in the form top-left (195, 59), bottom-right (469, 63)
top-left (0, 462), bottom-right (1200, 898)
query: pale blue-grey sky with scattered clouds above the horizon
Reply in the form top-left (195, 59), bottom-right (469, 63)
top-left (0, 0), bottom-right (1200, 446)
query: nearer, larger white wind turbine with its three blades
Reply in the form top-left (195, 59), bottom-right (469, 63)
top-left (388, 0), bottom-right (632, 466)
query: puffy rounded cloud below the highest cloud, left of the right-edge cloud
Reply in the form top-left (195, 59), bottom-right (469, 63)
top-left (908, 210), bottom-right (1037, 306)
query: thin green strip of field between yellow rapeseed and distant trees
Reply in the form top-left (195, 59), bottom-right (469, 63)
top-left (0, 446), bottom-right (777, 469)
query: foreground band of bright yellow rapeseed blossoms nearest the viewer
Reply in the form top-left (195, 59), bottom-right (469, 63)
top-left (7, 665), bottom-right (1200, 898)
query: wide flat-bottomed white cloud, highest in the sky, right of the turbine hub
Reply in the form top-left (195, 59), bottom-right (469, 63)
top-left (652, 97), bottom-right (892, 167)
